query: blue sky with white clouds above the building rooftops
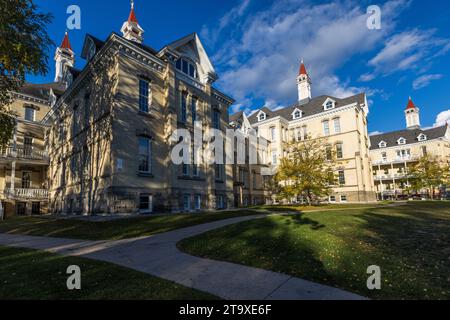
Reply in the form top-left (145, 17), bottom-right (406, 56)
top-left (28, 0), bottom-right (450, 132)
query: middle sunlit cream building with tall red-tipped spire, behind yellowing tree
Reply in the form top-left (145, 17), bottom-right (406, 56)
top-left (233, 61), bottom-right (376, 202)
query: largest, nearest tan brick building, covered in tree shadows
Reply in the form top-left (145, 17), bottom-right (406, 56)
top-left (45, 3), bottom-right (239, 214)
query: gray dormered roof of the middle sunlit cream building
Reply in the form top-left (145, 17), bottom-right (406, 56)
top-left (244, 93), bottom-right (366, 124)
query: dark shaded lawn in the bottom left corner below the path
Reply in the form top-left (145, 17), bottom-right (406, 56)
top-left (0, 246), bottom-right (217, 300)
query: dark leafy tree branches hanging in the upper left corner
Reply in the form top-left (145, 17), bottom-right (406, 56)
top-left (0, 0), bottom-right (53, 149)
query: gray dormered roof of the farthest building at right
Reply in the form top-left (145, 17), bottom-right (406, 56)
top-left (370, 125), bottom-right (447, 150)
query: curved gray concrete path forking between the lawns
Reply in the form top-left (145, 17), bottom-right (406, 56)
top-left (0, 215), bottom-right (365, 300)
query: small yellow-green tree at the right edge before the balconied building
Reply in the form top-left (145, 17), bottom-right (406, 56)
top-left (408, 155), bottom-right (450, 199)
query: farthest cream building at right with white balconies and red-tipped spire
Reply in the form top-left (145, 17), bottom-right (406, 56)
top-left (370, 98), bottom-right (450, 200)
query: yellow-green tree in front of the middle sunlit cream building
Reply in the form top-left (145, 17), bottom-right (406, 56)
top-left (277, 138), bottom-right (336, 205)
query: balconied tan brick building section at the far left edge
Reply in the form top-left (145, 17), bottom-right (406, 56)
top-left (0, 83), bottom-right (64, 216)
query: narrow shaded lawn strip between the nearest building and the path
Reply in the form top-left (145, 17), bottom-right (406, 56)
top-left (0, 210), bottom-right (264, 240)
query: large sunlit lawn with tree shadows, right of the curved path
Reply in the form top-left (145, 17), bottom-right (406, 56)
top-left (179, 202), bottom-right (450, 299)
